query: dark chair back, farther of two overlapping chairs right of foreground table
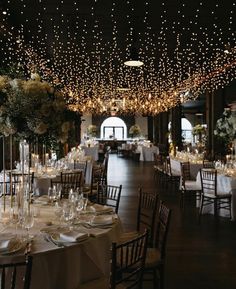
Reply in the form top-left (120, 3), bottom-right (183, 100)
top-left (136, 188), bottom-right (159, 246)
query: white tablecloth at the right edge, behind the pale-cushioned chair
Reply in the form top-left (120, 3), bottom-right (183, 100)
top-left (196, 172), bottom-right (236, 220)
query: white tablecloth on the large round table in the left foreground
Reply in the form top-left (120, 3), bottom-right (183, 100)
top-left (0, 202), bottom-right (121, 289)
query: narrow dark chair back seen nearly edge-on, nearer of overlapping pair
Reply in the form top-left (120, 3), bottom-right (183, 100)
top-left (155, 201), bottom-right (171, 260)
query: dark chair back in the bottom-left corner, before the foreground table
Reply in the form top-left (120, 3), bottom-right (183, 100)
top-left (0, 256), bottom-right (32, 289)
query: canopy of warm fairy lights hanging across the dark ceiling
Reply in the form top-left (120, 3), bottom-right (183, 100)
top-left (0, 0), bottom-right (236, 115)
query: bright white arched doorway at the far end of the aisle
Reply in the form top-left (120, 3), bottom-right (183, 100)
top-left (100, 116), bottom-right (127, 140)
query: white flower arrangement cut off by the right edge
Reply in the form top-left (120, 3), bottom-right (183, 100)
top-left (214, 109), bottom-right (236, 143)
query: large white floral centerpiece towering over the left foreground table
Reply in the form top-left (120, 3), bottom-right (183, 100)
top-left (0, 73), bottom-right (72, 143)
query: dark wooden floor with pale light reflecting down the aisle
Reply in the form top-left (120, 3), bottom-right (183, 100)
top-left (108, 154), bottom-right (236, 289)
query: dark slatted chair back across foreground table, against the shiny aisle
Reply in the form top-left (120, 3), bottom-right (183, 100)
top-left (97, 185), bottom-right (122, 214)
